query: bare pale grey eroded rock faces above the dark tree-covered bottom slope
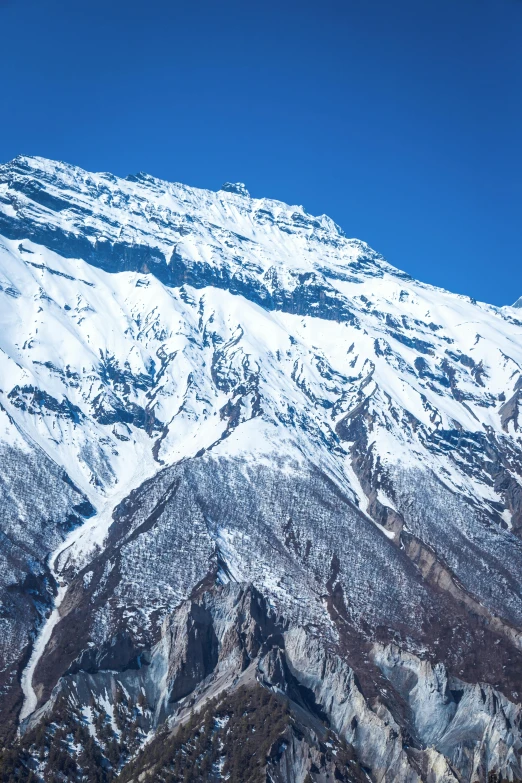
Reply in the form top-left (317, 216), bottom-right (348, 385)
top-left (10, 583), bottom-right (522, 783)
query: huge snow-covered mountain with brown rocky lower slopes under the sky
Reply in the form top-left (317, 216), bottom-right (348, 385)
top-left (0, 157), bottom-right (522, 781)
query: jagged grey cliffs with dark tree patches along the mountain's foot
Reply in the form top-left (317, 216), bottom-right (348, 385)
top-left (10, 583), bottom-right (522, 781)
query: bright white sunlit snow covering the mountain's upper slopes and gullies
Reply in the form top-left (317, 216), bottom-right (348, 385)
top-left (0, 158), bottom-right (522, 716)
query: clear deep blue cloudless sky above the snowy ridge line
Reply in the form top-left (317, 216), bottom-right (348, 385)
top-left (0, 0), bottom-right (522, 304)
